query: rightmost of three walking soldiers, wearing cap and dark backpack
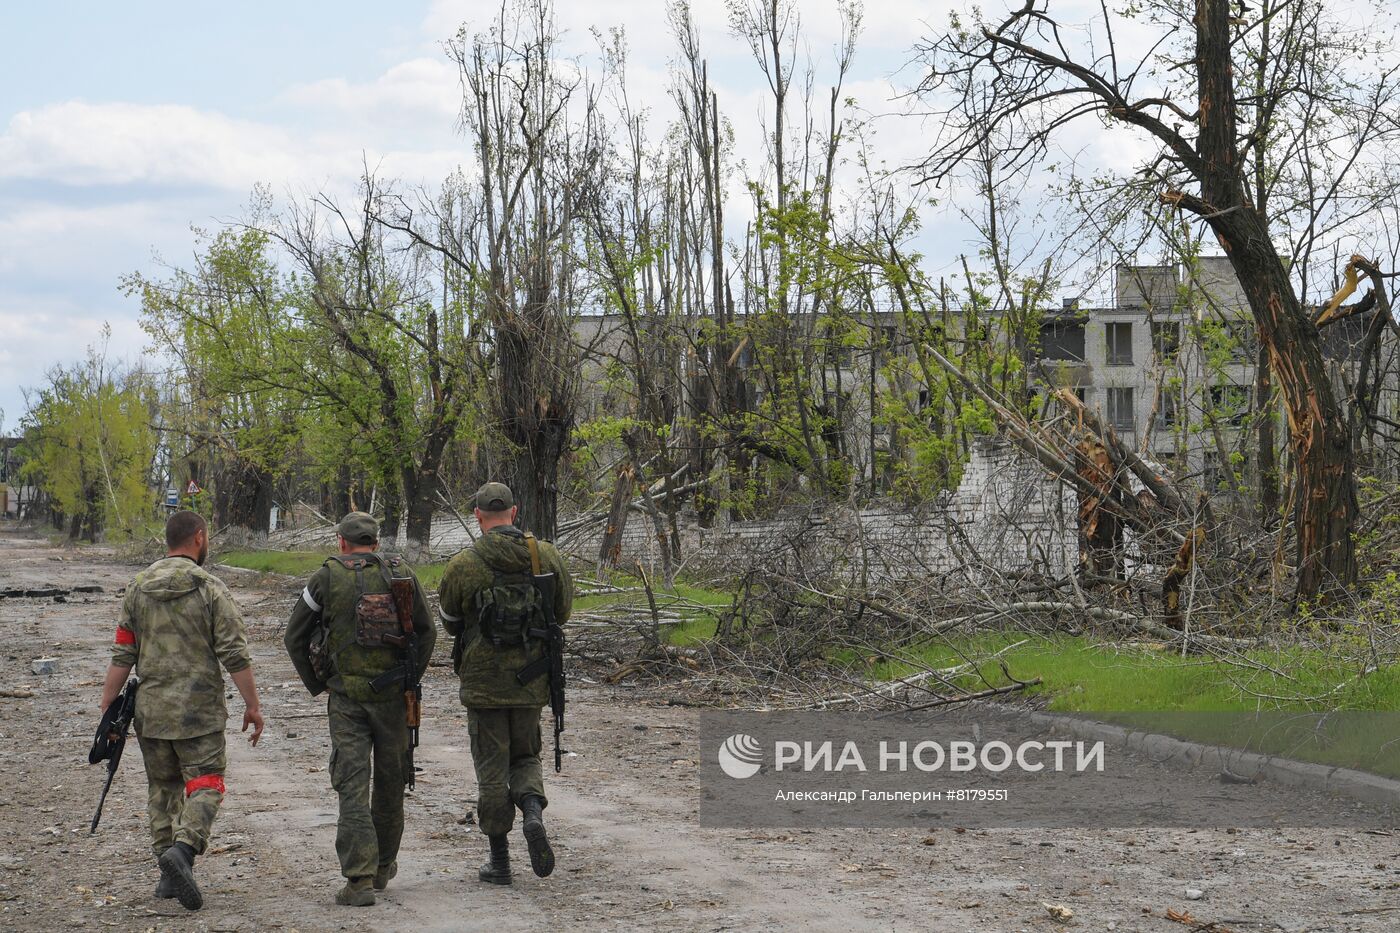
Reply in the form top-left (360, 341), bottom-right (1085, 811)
top-left (438, 483), bottom-right (573, 884)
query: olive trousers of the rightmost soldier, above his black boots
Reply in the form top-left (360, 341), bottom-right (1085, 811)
top-left (466, 706), bottom-right (545, 836)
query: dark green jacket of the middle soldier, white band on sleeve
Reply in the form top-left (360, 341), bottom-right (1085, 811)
top-left (283, 552), bottom-right (437, 703)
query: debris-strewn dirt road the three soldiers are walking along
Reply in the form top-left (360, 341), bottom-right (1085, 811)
top-left (0, 527), bottom-right (1400, 933)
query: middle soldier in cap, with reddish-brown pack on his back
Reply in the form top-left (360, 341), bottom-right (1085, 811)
top-left (284, 511), bottom-right (437, 906)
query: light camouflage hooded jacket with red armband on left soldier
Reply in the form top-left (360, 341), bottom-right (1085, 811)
top-left (112, 558), bottom-right (252, 738)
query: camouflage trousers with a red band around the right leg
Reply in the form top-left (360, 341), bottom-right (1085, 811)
top-left (139, 731), bottom-right (227, 857)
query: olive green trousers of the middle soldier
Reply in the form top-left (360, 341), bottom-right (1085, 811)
top-left (328, 691), bottom-right (409, 878)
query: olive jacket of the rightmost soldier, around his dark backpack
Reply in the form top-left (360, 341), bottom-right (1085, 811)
top-left (438, 525), bottom-right (574, 709)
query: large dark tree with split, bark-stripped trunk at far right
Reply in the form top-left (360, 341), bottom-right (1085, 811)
top-left (920, 0), bottom-right (1400, 595)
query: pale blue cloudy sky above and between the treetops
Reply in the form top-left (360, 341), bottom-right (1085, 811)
top-left (0, 0), bottom-right (1125, 433)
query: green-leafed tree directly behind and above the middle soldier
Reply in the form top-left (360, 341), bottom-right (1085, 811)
top-left (274, 175), bottom-right (486, 553)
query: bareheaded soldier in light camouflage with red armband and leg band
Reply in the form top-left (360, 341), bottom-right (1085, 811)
top-left (102, 511), bottom-right (263, 911)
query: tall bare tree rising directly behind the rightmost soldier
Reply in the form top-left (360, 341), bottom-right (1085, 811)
top-left (406, 0), bottom-right (599, 537)
